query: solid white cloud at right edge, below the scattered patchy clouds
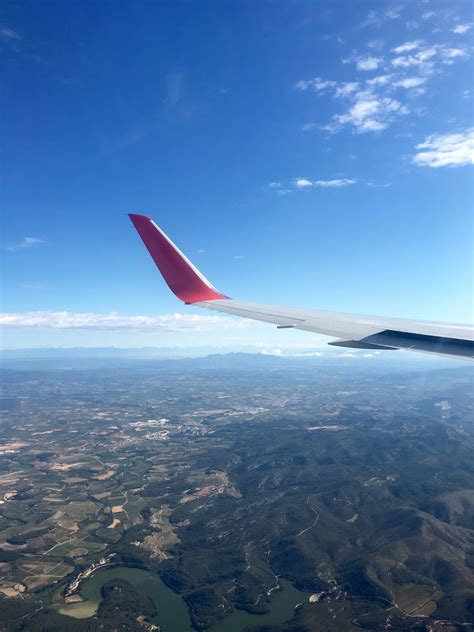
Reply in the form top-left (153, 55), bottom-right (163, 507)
top-left (413, 128), bottom-right (474, 168)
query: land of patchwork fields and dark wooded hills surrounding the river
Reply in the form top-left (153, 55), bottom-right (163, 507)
top-left (0, 358), bottom-right (474, 632)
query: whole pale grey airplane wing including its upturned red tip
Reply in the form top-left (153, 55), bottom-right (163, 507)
top-left (129, 214), bottom-right (474, 360)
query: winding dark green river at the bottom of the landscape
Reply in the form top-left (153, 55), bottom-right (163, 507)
top-left (59, 567), bottom-right (309, 632)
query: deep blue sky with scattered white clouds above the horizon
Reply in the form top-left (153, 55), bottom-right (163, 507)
top-left (0, 0), bottom-right (474, 348)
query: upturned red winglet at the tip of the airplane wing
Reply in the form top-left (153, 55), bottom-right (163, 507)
top-left (129, 214), bottom-right (228, 303)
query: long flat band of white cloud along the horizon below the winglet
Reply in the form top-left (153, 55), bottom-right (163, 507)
top-left (0, 311), bottom-right (254, 332)
